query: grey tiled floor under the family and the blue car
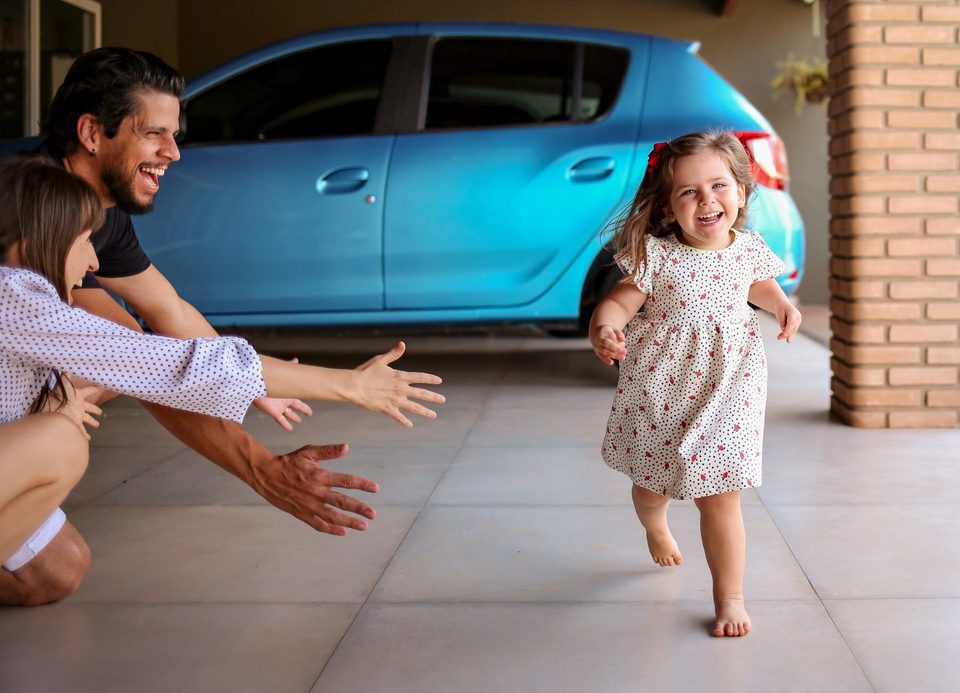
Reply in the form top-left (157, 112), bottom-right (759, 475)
top-left (0, 311), bottom-right (960, 693)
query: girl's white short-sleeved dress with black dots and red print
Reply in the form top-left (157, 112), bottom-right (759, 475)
top-left (602, 230), bottom-right (784, 499)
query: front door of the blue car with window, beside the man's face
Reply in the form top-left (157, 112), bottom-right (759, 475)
top-left (137, 38), bottom-right (393, 316)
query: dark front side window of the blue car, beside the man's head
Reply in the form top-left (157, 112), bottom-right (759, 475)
top-left (184, 40), bottom-right (392, 144)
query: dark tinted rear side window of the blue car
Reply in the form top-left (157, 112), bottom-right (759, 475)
top-left (426, 38), bottom-right (628, 129)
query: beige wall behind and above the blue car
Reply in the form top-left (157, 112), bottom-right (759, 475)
top-left (103, 0), bottom-right (829, 303)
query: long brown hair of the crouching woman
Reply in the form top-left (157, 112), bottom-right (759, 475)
top-left (0, 155), bottom-right (104, 413)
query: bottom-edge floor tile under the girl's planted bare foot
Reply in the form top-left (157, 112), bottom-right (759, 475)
top-left (313, 601), bottom-right (871, 693)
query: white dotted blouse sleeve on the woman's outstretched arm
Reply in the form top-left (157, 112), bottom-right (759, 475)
top-left (0, 270), bottom-right (266, 422)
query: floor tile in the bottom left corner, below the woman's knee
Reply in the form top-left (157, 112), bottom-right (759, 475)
top-left (0, 603), bottom-right (358, 693)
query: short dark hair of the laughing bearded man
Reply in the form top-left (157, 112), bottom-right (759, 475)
top-left (44, 48), bottom-right (183, 157)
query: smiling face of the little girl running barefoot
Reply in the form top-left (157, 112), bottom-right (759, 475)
top-left (664, 151), bottom-right (746, 250)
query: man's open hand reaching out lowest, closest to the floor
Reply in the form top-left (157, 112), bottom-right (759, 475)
top-left (250, 443), bottom-right (379, 536)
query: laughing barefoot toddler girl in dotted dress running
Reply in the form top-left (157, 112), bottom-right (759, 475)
top-left (589, 132), bottom-right (800, 637)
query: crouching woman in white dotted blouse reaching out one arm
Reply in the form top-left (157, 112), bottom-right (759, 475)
top-left (0, 157), bottom-right (444, 580)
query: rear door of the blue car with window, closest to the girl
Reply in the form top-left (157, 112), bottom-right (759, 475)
top-left (384, 32), bottom-right (638, 314)
